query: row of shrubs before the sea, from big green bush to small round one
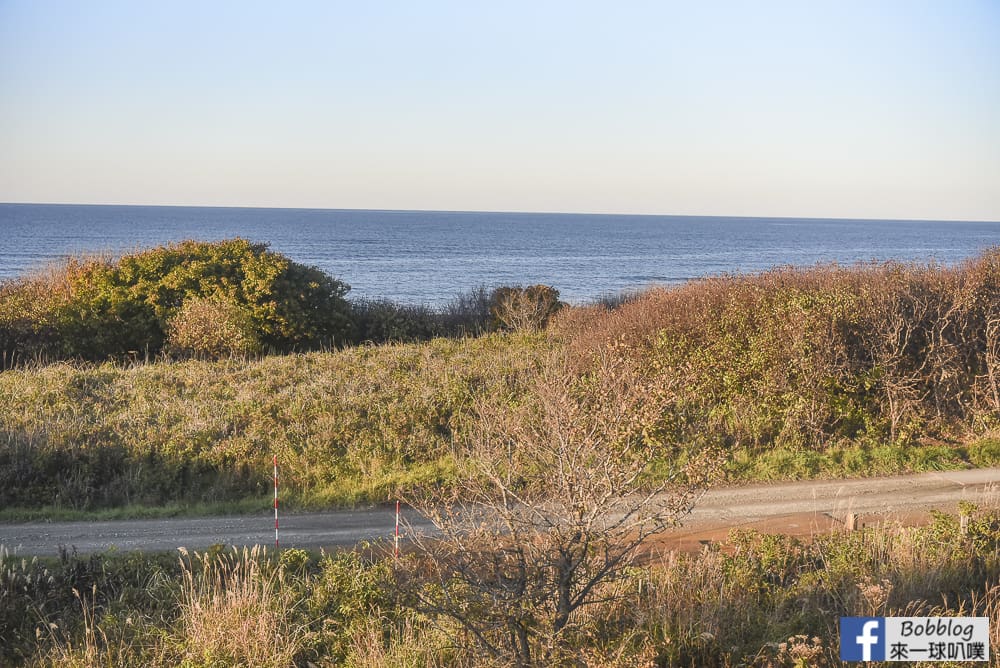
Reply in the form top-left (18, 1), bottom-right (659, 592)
top-left (0, 239), bottom-right (528, 362)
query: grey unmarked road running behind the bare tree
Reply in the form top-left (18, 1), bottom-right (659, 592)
top-left (0, 468), bottom-right (1000, 555)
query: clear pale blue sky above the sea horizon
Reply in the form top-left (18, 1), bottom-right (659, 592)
top-left (0, 0), bottom-right (1000, 220)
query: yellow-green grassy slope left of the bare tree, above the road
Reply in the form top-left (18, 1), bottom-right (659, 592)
top-left (0, 335), bottom-right (548, 509)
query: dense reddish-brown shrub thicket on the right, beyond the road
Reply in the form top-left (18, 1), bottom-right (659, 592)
top-left (554, 249), bottom-right (1000, 452)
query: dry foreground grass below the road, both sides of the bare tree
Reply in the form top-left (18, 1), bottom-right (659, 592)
top-left (15, 507), bottom-right (1000, 668)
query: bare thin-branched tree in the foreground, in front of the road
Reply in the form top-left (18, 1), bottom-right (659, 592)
top-left (402, 349), bottom-right (717, 666)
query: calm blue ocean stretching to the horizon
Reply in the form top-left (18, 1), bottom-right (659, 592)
top-left (0, 204), bottom-right (1000, 305)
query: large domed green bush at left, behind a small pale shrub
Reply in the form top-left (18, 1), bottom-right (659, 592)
top-left (0, 239), bottom-right (351, 360)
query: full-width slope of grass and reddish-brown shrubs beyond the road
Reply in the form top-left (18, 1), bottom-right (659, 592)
top-left (0, 252), bottom-right (1000, 518)
